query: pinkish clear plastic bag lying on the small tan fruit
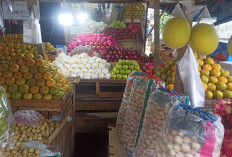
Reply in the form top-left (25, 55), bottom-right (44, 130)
top-left (14, 110), bottom-right (40, 125)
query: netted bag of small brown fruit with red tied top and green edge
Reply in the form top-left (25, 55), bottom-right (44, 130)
top-left (121, 75), bottom-right (165, 152)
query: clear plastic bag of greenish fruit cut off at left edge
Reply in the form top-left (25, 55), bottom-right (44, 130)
top-left (0, 86), bottom-right (14, 147)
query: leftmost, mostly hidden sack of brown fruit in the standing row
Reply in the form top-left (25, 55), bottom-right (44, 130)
top-left (116, 73), bottom-right (146, 140)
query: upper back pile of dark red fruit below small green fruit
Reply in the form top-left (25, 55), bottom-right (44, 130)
top-left (103, 27), bottom-right (136, 40)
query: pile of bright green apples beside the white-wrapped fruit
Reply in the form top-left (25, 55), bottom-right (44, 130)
top-left (111, 60), bottom-right (142, 79)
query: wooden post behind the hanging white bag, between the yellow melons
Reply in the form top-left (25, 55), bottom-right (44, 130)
top-left (174, 0), bottom-right (195, 93)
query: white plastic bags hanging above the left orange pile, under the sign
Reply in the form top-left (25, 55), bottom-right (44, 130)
top-left (23, 18), bottom-right (42, 44)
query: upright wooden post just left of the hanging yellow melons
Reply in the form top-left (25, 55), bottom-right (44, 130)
top-left (153, 0), bottom-right (160, 74)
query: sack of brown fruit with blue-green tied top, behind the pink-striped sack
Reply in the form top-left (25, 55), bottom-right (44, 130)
top-left (133, 88), bottom-right (189, 157)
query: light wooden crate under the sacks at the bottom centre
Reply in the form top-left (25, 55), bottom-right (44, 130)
top-left (108, 125), bottom-right (127, 157)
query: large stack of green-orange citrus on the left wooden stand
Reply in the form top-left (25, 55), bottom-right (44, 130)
top-left (0, 50), bottom-right (70, 100)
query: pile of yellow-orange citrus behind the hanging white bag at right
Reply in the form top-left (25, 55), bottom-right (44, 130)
top-left (158, 53), bottom-right (232, 99)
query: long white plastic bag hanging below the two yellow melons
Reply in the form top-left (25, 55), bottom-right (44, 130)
top-left (177, 45), bottom-right (205, 107)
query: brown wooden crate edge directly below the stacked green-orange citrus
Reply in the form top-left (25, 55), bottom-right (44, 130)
top-left (9, 85), bottom-right (75, 118)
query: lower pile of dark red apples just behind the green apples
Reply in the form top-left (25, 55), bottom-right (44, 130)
top-left (99, 47), bottom-right (145, 63)
